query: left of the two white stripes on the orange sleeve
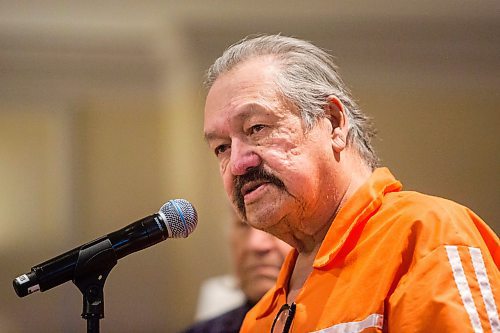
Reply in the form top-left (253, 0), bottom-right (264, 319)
top-left (445, 245), bottom-right (483, 333)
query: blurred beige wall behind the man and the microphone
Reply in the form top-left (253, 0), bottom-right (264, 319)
top-left (0, 1), bottom-right (500, 332)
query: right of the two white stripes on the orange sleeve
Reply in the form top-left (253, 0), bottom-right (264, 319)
top-left (469, 247), bottom-right (500, 332)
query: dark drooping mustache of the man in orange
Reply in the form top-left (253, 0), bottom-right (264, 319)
top-left (233, 166), bottom-right (285, 220)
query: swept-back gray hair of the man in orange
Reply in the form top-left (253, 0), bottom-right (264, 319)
top-left (205, 35), bottom-right (378, 169)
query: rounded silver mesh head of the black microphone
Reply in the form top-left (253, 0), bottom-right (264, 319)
top-left (158, 199), bottom-right (198, 238)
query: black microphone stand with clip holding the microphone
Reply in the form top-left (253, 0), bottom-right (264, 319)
top-left (73, 237), bottom-right (118, 333)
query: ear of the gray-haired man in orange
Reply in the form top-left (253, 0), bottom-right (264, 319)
top-left (325, 95), bottom-right (349, 153)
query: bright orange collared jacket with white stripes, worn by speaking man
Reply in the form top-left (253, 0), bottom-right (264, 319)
top-left (241, 168), bottom-right (500, 333)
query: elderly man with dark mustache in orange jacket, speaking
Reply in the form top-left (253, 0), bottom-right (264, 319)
top-left (204, 36), bottom-right (500, 333)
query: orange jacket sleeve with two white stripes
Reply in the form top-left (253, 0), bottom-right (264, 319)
top-left (386, 245), bottom-right (500, 333)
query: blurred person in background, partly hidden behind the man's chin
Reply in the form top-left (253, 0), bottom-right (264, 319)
top-left (184, 209), bottom-right (291, 333)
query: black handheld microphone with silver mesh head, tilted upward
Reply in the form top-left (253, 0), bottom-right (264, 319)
top-left (13, 199), bottom-right (198, 297)
